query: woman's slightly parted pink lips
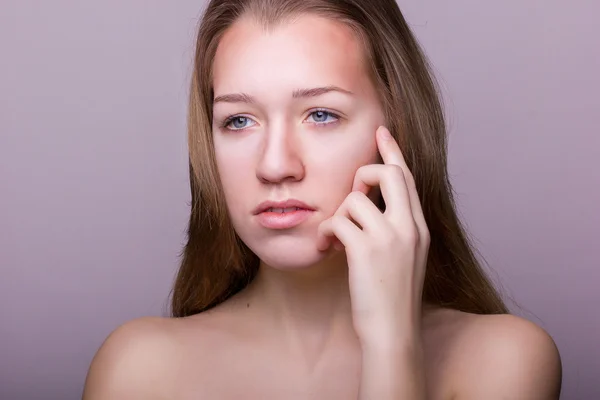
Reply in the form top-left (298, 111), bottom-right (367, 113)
top-left (254, 199), bottom-right (315, 229)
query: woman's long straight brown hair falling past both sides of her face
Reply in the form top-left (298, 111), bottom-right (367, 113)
top-left (172, 0), bottom-right (507, 317)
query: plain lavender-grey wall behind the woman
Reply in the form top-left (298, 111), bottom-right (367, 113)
top-left (0, 0), bottom-right (600, 400)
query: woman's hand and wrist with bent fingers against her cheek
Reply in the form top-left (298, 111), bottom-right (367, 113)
top-left (317, 127), bottom-right (430, 344)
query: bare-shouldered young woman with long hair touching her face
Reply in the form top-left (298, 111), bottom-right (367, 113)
top-left (84, 0), bottom-right (561, 400)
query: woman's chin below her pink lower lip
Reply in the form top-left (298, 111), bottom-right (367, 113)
top-left (246, 236), bottom-right (326, 270)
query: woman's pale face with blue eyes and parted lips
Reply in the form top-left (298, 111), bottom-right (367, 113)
top-left (212, 15), bottom-right (384, 269)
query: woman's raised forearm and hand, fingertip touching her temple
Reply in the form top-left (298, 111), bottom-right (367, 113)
top-left (317, 127), bottom-right (430, 400)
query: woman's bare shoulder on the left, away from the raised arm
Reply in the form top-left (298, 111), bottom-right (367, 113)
top-left (83, 307), bottom-right (243, 400)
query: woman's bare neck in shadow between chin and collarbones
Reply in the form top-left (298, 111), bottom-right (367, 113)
top-left (239, 253), bottom-right (355, 351)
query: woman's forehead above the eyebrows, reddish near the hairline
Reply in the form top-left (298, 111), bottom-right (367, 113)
top-left (213, 15), bottom-right (369, 96)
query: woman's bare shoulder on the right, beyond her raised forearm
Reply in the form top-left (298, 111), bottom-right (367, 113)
top-left (428, 311), bottom-right (562, 400)
